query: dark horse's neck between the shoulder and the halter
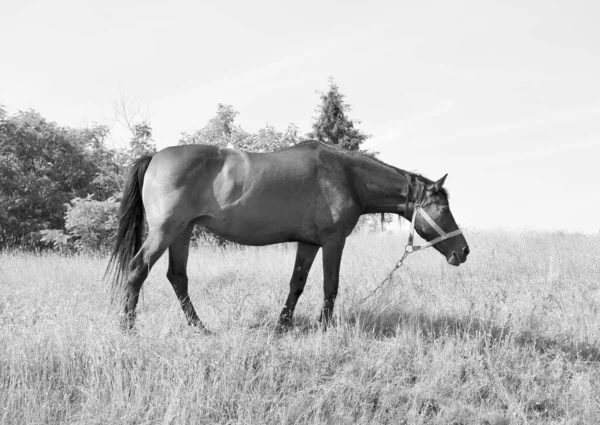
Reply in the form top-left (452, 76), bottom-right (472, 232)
top-left (353, 158), bottom-right (408, 214)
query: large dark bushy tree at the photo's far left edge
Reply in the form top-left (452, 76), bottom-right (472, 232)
top-left (0, 110), bottom-right (106, 246)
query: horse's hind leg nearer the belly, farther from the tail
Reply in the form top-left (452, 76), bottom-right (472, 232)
top-left (167, 223), bottom-right (209, 329)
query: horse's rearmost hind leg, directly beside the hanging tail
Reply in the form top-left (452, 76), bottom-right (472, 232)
top-left (122, 220), bottom-right (187, 329)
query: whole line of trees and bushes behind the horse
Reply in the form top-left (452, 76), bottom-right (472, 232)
top-left (0, 80), bottom-right (390, 251)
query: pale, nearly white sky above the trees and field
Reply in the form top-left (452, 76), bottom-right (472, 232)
top-left (0, 0), bottom-right (600, 234)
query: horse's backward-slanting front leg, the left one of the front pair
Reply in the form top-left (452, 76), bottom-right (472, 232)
top-left (277, 242), bottom-right (319, 331)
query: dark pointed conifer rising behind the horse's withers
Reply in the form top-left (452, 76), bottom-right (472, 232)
top-left (307, 78), bottom-right (371, 151)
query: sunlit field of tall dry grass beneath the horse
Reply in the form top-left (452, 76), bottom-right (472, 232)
top-left (0, 232), bottom-right (600, 425)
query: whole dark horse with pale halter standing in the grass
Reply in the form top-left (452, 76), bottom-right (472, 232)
top-left (107, 141), bottom-right (469, 328)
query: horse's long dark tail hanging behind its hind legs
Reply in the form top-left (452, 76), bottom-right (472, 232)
top-left (104, 155), bottom-right (152, 301)
